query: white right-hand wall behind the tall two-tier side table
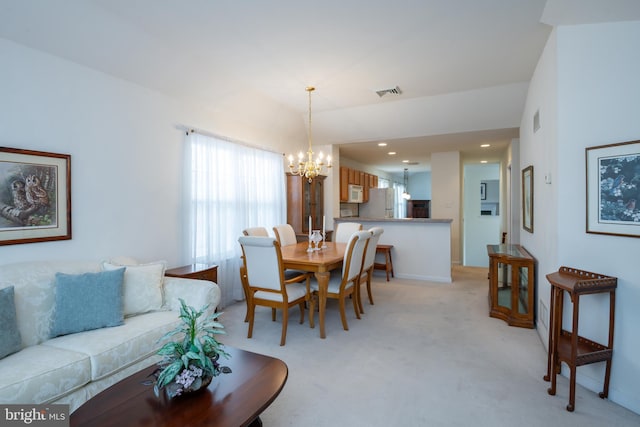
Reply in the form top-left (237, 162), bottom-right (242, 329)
top-left (520, 22), bottom-right (640, 413)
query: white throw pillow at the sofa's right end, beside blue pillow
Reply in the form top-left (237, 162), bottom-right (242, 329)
top-left (102, 262), bottom-right (166, 316)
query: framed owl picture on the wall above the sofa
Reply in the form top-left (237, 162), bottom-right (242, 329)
top-left (0, 147), bottom-right (71, 245)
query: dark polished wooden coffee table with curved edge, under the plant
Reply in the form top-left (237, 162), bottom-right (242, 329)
top-left (70, 347), bottom-right (288, 427)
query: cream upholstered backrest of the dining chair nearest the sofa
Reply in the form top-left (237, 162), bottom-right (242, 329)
top-left (238, 236), bottom-right (284, 291)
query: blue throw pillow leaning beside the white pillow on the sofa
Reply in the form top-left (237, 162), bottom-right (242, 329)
top-left (51, 268), bottom-right (125, 338)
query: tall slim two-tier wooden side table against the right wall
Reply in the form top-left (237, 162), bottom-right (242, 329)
top-left (544, 267), bottom-right (618, 412)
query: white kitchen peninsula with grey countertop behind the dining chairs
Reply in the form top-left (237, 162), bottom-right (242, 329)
top-left (333, 217), bottom-right (452, 283)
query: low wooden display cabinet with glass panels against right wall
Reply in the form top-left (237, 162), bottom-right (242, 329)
top-left (487, 245), bottom-right (536, 328)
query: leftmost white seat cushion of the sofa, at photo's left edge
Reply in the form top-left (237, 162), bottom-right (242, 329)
top-left (0, 345), bottom-right (91, 404)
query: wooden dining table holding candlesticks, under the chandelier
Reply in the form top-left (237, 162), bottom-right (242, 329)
top-left (281, 242), bottom-right (347, 338)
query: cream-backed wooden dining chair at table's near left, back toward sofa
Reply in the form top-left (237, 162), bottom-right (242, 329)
top-left (238, 236), bottom-right (310, 345)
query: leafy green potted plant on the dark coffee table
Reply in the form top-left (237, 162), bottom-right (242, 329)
top-left (153, 299), bottom-right (231, 398)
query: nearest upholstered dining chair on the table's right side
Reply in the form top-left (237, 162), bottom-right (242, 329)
top-left (309, 231), bottom-right (371, 331)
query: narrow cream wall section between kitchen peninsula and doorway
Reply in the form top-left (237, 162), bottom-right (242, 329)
top-left (431, 151), bottom-right (462, 264)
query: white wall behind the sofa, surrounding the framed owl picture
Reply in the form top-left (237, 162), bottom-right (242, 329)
top-left (0, 39), bottom-right (306, 266)
